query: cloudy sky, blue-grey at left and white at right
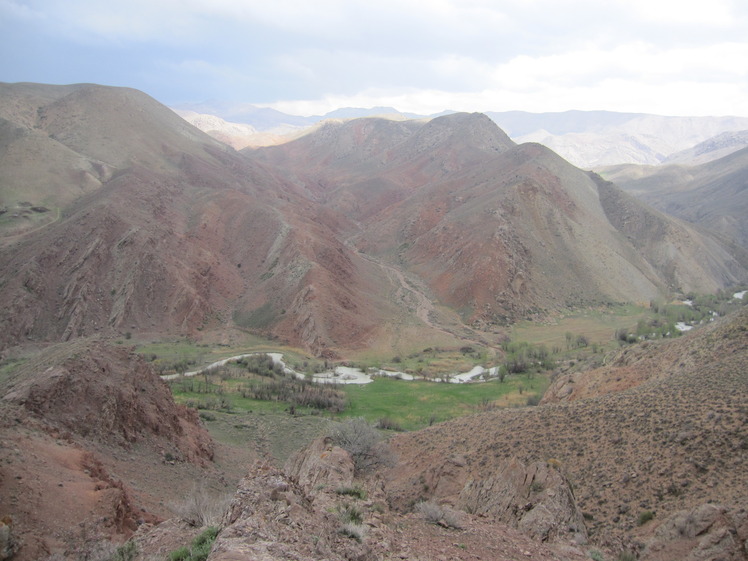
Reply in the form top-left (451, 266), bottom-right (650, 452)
top-left (0, 0), bottom-right (748, 117)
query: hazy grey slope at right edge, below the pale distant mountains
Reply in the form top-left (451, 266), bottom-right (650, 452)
top-left (603, 148), bottom-right (748, 249)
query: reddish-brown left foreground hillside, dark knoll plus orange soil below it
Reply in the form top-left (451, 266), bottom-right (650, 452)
top-left (0, 338), bottom-right (214, 561)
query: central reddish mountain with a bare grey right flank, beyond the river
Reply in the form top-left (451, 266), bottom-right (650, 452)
top-left (253, 114), bottom-right (743, 323)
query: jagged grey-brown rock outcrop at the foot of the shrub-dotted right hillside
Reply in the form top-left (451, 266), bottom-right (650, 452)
top-left (459, 459), bottom-right (587, 544)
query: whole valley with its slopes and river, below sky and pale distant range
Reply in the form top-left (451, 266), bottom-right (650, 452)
top-left (0, 83), bottom-right (748, 561)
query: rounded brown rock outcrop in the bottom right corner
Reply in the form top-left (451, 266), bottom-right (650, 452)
top-left (641, 502), bottom-right (748, 561)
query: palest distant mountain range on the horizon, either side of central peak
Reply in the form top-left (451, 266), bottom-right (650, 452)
top-left (175, 104), bottom-right (748, 169)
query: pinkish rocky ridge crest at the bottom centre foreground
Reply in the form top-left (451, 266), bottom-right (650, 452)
top-left (203, 458), bottom-right (586, 561)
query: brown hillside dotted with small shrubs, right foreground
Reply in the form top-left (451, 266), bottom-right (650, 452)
top-left (388, 309), bottom-right (748, 558)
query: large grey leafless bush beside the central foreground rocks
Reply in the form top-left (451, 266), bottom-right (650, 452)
top-left (330, 417), bottom-right (394, 473)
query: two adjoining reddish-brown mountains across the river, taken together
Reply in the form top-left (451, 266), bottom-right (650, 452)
top-left (0, 84), bottom-right (746, 354)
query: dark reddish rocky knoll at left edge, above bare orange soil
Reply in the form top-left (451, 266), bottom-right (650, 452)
top-left (3, 339), bottom-right (213, 463)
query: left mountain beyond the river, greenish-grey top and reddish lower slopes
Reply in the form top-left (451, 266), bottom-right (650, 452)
top-left (0, 85), bottom-right (400, 352)
